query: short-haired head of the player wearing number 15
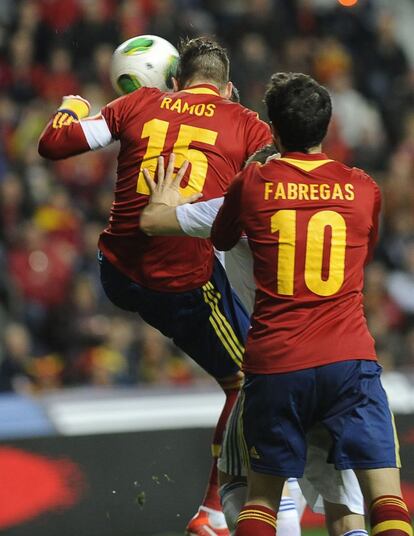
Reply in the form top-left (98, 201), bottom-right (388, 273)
top-left (177, 37), bottom-right (230, 88)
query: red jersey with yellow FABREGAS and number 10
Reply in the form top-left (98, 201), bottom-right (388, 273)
top-left (211, 153), bottom-right (381, 374)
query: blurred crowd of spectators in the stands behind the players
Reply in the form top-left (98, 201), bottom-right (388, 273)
top-left (0, 0), bottom-right (414, 391)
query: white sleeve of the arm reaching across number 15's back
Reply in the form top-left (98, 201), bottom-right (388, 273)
top-left (175, 197), bottom-right (224, 238)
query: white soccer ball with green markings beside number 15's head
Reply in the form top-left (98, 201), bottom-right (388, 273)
top-left (110, 35), bottom-right (179, 95)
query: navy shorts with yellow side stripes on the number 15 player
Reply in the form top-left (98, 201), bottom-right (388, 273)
top-left (99, 256), bottom-right (250, 379)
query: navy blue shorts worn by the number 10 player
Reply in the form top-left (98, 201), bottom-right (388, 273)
top-left (242, 360), bottom-right (400, 478)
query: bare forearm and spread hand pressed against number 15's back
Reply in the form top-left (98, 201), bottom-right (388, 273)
top-left (140, 154), bottom-right (202, 236)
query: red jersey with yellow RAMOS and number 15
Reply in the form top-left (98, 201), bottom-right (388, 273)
top-left (39, 84), bottom-right (271, 292)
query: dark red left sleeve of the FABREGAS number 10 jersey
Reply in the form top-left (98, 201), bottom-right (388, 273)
top-left (211, 171), bottom-right (246, 251)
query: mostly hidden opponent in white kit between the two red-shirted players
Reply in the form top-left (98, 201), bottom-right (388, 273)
top-left (141, 152), bottom-right (368, 536)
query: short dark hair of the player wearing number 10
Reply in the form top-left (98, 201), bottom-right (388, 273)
top-left (264, 73), bottom-right (332, 152)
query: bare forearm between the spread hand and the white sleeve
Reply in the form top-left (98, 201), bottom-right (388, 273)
top-left (140, 203), bottom-right (185, 236)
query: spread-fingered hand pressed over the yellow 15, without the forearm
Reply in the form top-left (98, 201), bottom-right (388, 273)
top-left (142, 153), bottom-right (203, 207)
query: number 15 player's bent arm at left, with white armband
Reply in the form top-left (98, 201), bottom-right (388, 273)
top-left (38, 95), bottom-right (112, 160)
